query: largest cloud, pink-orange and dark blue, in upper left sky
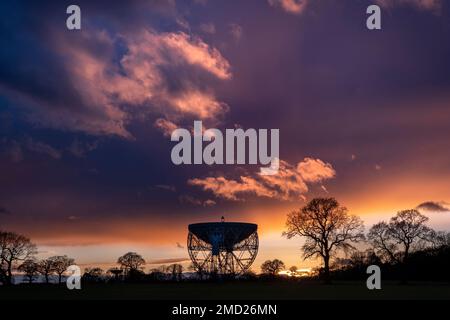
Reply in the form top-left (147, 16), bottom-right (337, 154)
top-left (0, 23), bottom-right (231, 139)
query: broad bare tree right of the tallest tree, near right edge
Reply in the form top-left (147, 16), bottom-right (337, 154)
top-left (367, 209), bottom-right (436, 264)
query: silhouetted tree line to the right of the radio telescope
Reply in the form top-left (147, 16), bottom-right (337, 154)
top-left (261, 198), bottom-right (450, 283)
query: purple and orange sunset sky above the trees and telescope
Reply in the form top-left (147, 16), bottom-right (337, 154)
top-left (0, 0), bottom-right (450, 270)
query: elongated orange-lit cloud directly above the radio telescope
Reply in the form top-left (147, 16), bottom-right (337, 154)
top-left (188, 158), bottom-right (336, 201)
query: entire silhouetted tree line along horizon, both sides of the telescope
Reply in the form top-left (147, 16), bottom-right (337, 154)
top-left (0, 198), bottom-right (450, 285)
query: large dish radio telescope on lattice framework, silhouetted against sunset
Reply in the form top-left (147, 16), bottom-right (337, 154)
top-left (187, 217), bottom-right (258, 275)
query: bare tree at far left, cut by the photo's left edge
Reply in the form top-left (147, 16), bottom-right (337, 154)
top-left (0, 231), bottom-right (37, 285)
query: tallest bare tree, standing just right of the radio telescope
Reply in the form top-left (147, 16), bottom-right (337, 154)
top-left (283, 198), bottom-right (364, 283)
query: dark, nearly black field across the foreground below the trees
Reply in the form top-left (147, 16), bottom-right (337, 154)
top-left (0, 282), bottom-right (450, 300)
